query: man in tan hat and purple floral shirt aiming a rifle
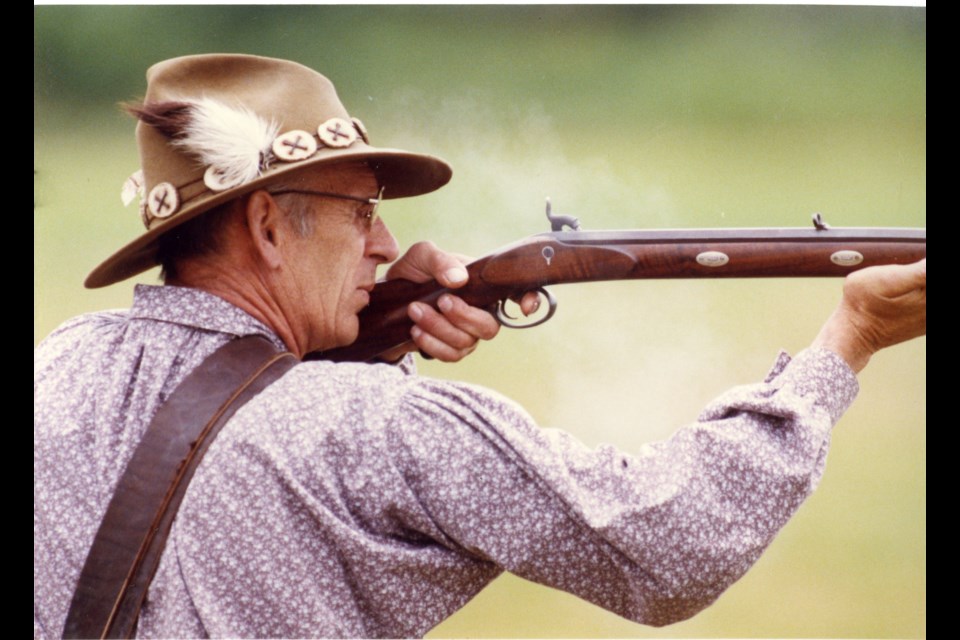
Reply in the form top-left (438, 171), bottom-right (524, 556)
top-left (34, 55), bottom-right (926, 637)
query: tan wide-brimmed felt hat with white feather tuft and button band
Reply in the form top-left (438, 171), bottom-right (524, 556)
top-left (84, 54), bottom-right (452, 288)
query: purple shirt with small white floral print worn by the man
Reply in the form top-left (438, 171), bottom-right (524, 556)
top-left (33, 286), bottom-right (857, 638)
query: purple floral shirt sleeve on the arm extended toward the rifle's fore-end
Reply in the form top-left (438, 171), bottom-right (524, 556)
top-left (391, 350), bottom-right (858, 626)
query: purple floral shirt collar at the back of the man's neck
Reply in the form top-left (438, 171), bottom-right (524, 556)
top-left (130, 284), bottom-right (287, 351)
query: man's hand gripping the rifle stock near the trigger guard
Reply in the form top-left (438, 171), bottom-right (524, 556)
top-left (386, 242), bottom-right (538, 362)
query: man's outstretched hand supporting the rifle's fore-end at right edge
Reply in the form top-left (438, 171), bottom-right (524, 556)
top-left (813, 260), bottom-right (927, 372)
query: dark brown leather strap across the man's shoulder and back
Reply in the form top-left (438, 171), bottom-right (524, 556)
top-left (63, 336), bottom-right (298, 638)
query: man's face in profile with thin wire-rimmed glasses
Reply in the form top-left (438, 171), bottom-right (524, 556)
top-left (274, 165), bottom-right (399, 351)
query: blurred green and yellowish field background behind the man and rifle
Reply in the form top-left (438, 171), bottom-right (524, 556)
top-left (34, 5), bottom-right (926, 637)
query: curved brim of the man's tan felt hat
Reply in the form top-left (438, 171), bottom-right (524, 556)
top-left (83, 142), bottom-right (453, 289)
